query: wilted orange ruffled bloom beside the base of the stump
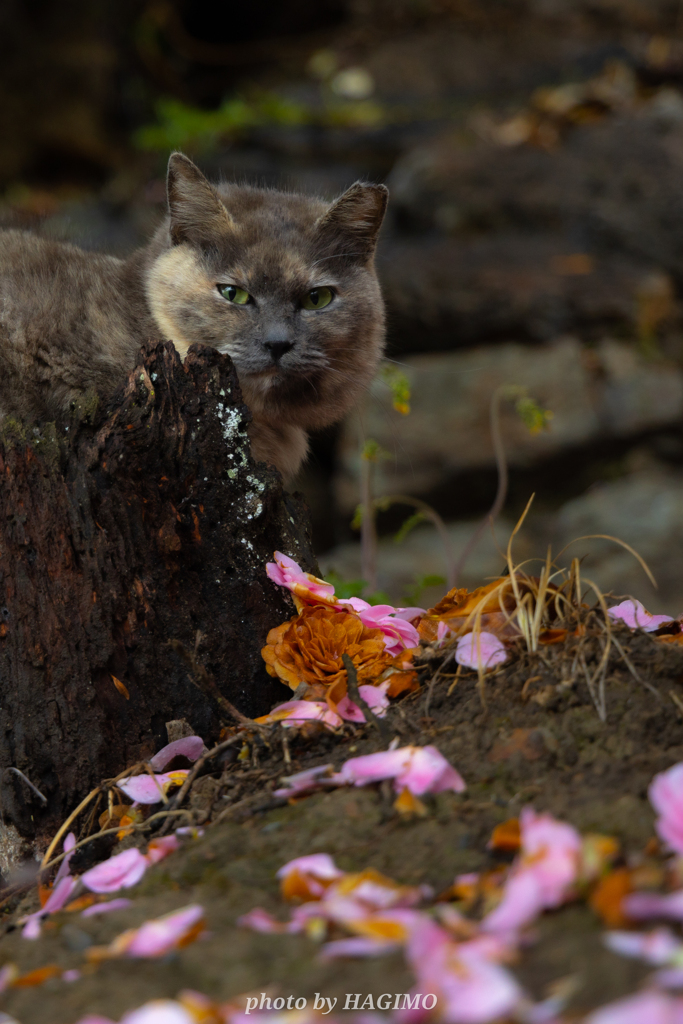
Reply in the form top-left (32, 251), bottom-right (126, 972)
top-left (261, 605), bottom-right (395, 710)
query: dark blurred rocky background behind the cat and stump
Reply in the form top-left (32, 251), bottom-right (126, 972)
top-left (0, 0), bottom-right (683, 614)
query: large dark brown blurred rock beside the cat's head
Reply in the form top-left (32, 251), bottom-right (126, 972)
top-left (380, 107), bottom-right (683, 350)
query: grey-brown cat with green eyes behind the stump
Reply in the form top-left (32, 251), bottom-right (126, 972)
top-left (0, 153), bottom-right (388, 482)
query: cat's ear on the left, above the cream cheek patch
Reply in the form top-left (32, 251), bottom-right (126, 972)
top-left (166, 153), bottom-right (232, 246)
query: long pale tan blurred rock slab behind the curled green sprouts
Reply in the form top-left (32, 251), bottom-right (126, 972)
top-left (336, 338), bottom-right (683, 510)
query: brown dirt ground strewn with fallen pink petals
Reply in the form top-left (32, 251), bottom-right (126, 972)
top-left (0, 628), bottom-right (683, 1024)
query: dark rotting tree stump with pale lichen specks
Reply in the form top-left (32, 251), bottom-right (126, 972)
top-left (0, 343), bottom-right (315, 838)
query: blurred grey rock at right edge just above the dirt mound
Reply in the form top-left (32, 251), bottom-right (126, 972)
top-left (553, 466), bottom-right (683, 615)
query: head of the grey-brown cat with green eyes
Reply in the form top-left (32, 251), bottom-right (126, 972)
top-left (146, 153), bottom-right (388, 429)
